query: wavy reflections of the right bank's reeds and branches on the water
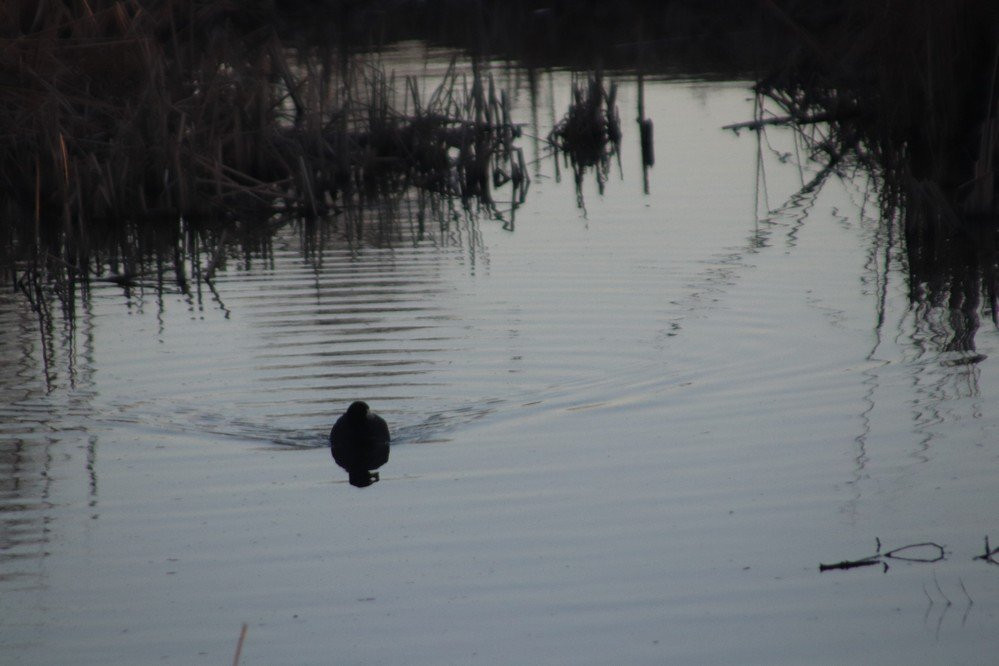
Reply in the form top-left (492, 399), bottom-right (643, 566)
top-left (747, 124), bottom-right (995, 506)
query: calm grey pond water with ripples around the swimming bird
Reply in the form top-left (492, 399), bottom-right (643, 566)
top-left (0, 49), bottom-right (999, 664)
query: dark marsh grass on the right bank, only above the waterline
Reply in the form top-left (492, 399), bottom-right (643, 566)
top-left (756, 0), bottom-right (999, 217)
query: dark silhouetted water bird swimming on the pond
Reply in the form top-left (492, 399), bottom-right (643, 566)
top-left (330, 400), bottom-right (391, 488)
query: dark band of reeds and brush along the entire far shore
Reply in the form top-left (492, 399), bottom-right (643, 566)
top-left (0, 0), bottom-right (999, 342)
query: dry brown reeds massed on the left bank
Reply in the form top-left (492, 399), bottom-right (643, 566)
top-left (0, 0), bottom-right (527, 312)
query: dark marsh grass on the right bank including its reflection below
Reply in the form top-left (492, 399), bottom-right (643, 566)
top-left (746, 0), bottom-right (999, 340)
